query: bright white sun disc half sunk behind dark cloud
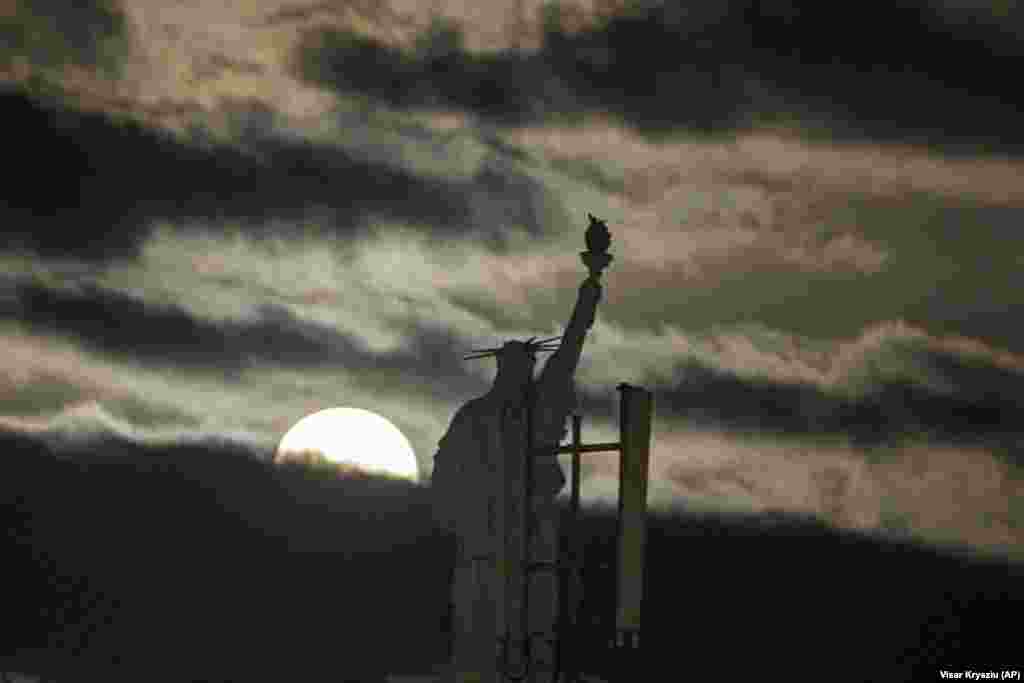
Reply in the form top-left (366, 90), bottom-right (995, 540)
top-left (274, 408), bottom-right (419, 481)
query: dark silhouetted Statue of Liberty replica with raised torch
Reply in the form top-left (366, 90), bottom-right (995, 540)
top-left (432, 216), bottom-right (612, 683)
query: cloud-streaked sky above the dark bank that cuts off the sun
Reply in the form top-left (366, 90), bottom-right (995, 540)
top-left (6, 0), bottom-right (1024, 679)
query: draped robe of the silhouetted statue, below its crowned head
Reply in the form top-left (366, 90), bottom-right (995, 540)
top-left (434, 374), bottom-right (574, 680)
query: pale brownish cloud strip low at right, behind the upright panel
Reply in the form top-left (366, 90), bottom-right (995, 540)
top-left (606, 428), bottom-right (1024, 553)
